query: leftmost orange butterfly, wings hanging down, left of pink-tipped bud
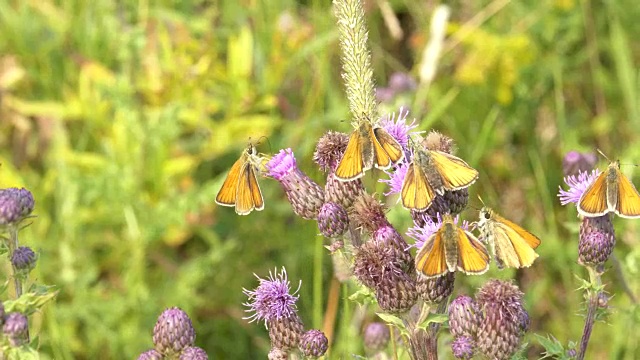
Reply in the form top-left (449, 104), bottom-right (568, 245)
top-left (216, 144), bottom-right (264, 215)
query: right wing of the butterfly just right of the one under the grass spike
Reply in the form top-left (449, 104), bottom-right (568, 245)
top-left (431, 151), bottom-right (478, 190)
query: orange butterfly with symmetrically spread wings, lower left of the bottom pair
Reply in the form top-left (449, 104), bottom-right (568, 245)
top-left (416, 214), bottom-right (489, 278)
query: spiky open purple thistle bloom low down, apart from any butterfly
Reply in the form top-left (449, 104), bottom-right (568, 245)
top-left (242, 267), bottom-right (302, 326)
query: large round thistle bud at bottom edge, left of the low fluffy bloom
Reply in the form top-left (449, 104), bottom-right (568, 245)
top-left (153, 307), bottom-right (196, 356)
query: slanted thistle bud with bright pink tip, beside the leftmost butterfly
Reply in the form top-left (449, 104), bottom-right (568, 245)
top-left (266, 149), bottom-right (324, 219)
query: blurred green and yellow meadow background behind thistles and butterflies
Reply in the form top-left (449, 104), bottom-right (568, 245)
top-left (0, 0), bottom-right (640, 359)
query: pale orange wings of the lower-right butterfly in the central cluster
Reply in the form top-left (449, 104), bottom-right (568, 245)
top-left (493, 218), bottom-right (540, 268)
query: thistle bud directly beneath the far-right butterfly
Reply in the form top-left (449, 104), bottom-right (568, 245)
top-left (578, 215), bottom-right (616, 265)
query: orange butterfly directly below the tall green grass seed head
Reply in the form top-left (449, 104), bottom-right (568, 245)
top-left (335, 119), bottom-right (404, 181)
